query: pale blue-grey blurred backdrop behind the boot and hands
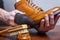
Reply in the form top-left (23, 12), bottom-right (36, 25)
top-left (3, 0), bottom-right (60, 25)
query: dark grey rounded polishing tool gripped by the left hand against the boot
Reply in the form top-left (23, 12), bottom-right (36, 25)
top-left (14, 13), bottom-right (34, 26)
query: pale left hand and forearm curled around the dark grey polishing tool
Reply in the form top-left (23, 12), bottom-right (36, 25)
top-left (0, 8), bottom-right (25, 26)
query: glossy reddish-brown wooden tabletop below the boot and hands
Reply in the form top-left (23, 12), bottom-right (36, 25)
top-left (0, 26), bottom-right (60, 40)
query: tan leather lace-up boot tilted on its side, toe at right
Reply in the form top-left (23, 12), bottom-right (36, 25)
top-left (15, 0), bottom-right (60, 22)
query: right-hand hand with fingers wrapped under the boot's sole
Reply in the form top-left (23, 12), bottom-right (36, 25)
top-left (38, 13), bottom-right (60, 32)
